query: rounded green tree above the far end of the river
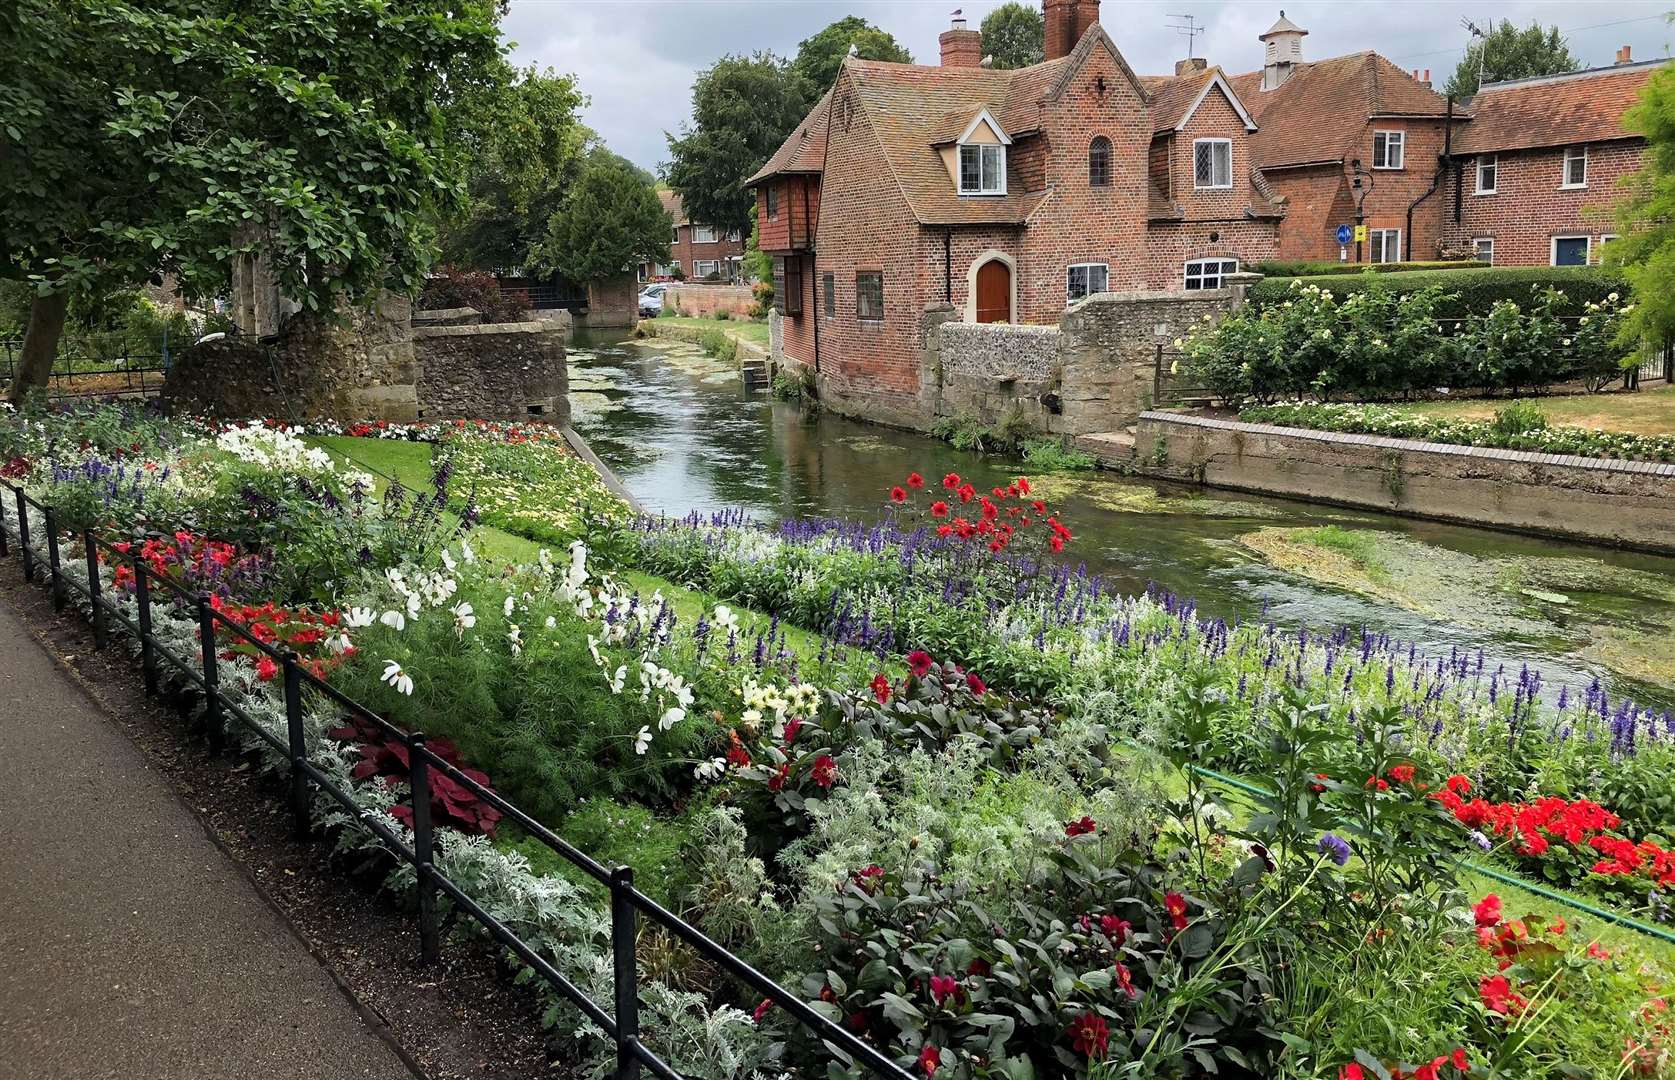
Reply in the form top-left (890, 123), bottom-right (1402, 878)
top-left (536, 146), bottom-right (675, 281)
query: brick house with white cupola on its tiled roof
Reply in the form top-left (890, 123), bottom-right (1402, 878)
top-left (1231, 12), bottom-right (1464, 263)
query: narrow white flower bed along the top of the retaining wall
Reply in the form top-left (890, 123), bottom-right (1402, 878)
top-left (1240, 404), bottom-right (1675, 462)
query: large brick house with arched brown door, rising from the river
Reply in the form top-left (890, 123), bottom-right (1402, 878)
top-left (749, 0), bottom-right (1285, 424)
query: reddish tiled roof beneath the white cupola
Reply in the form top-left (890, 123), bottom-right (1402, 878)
top-left (1228, 52), bottom-right (1469, 169)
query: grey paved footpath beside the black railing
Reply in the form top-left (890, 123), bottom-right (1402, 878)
top-left (0, 604), bottom-right (414, 1080)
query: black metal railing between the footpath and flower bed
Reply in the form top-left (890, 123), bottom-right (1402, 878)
top-left (0, 482), bottom-right (911, 1080)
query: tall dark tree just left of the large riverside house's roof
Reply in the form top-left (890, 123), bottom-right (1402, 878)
top-left (667, 52), bottom-right (811, 231)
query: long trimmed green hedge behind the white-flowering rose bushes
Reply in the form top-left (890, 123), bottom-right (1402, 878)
top-left (1250, 266), bottom-right (1633, 318)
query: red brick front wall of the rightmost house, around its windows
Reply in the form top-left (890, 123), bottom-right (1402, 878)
top-left (1439, 139), bottom-right (1645, 266)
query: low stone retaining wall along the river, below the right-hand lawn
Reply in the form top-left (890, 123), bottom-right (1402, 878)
top-left (1134, 412), bottom-right (1675, 553)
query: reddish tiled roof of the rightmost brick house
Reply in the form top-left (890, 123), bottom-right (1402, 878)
top-left (1456, 60), bottom-right (1665, 154)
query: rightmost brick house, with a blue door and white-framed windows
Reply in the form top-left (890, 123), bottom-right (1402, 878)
top-left (1444, 54), bottom-right (1663, 266)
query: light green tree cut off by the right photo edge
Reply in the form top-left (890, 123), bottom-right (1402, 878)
top-left (1606, 65), bottom-right (1675, 343)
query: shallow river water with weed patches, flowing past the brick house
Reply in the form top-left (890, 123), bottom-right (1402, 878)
top-left (570, 337), bottom-right (1675, 707)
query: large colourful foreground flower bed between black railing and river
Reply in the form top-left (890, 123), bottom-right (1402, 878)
top-left (0, 400), bottom-right (1668, 1080)
